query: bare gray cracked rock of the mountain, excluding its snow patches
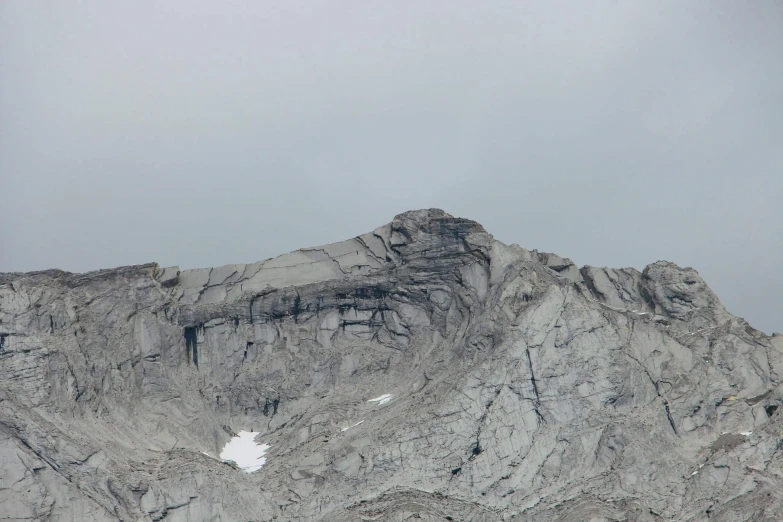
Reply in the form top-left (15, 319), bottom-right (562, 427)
top-left (0, 209), bottom-right (783, 522)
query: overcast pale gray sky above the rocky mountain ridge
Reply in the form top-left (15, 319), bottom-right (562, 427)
top-left (0, 0), bottom-right (783, 333)
